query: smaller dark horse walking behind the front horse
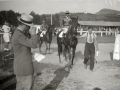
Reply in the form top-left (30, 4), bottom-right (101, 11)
top-left (39, 25), bottom-right (54, 54)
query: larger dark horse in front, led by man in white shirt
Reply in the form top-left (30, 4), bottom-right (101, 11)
top-left (57, 18), bottom-right (78, 69)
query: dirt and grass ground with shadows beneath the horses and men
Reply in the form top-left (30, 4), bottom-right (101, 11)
top-left (0, 35), bottom-right (120, 90)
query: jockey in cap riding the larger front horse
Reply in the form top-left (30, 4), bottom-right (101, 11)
top-left (62, 11), bottom-right (71, 37)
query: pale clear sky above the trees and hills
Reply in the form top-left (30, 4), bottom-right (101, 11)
top-left (0, 0), bottom-right (120, 15)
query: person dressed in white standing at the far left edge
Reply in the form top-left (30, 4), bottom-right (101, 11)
top-left (2, 21), bottom-right (11, 51)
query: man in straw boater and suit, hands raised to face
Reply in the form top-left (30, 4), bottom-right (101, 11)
top-left (12, 14), bottom-right (38, 90)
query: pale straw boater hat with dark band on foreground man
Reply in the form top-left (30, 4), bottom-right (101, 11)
top-left (17, 13), bottom-right (33, 26)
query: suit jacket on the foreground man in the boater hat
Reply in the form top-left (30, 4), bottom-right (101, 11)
top-left (12, 29), bottom-right (38, 75)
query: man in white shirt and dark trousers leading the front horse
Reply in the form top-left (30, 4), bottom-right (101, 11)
top-left (80, 27), bottom-right (99, 71)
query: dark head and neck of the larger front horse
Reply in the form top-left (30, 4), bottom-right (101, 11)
top-left (69, 17), bottom-right (79, 35)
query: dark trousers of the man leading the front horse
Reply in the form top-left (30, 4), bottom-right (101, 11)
top-left (84, 42), bottom-right (95, 70)
